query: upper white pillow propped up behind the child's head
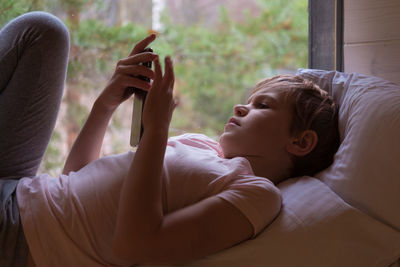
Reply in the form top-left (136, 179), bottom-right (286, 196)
top-left (298, 69), bottom-right (400, 231)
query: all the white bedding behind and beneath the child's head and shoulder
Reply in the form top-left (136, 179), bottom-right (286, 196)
top-left (148, 69), bottom-right (400, 267)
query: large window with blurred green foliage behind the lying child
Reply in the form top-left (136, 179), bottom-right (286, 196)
top-left (0, 0), bottom-right (309, 175)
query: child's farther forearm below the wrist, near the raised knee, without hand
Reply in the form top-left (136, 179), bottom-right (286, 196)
top-left (63, 101), bottom-right (114, 174)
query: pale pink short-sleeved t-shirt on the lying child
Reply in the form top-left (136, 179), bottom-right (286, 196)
top-left (17, 134), bottom-right (279, 266)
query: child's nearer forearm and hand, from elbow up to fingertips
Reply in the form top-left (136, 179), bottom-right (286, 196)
top-left (112, 57), bottom-right (175, 261)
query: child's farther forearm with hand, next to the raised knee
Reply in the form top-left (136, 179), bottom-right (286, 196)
top-left (63, 35), bottom-right (157, 174)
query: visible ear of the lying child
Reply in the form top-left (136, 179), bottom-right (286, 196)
top-left (286, 130), bottom-right (318, 157)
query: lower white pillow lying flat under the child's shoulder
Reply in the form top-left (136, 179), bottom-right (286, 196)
top-left (172, 176), bottom-right (400, 267)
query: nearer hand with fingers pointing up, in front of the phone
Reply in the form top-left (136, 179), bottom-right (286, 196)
top-left (142, 57), bottom-right (177, 134)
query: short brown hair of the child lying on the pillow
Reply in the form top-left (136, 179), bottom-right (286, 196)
top-left (253, 74), bottom-right (340, 177)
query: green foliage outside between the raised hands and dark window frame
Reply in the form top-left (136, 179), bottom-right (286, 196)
top-left (154, 0), bottom-right (308, 135)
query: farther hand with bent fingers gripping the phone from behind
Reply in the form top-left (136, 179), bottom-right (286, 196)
top-left (96, 34), bottom-right (158, 110)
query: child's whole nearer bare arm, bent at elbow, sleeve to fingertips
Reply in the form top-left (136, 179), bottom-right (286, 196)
top-left (112, 59), bottom-right (280, 264)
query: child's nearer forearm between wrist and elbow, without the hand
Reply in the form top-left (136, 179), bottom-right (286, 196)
top-left (115, 129), bottom-right (168, 244)
